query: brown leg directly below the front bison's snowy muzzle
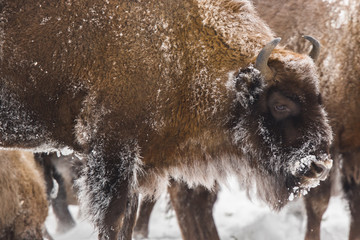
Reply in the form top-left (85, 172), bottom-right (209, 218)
top-left (305, 178), bottom-right (331, 240)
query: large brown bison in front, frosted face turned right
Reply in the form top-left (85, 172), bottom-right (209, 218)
top-left (0, 0), bottom-right (332, 239)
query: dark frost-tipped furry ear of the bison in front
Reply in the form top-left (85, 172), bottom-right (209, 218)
top-left (235, 66), bottom-right (265, 108)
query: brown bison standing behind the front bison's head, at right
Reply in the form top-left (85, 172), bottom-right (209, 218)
top-left (253, 0), bottom-right (360, 240)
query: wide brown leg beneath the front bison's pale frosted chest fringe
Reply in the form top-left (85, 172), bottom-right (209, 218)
top-left (168, 181), bottom-right (219, 240)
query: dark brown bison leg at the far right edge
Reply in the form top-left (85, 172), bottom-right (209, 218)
top-left (342, 151), bottom-right (360, 240)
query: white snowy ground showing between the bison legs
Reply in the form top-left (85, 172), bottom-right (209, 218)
top-left (46, 181), bottom-right (349, 240)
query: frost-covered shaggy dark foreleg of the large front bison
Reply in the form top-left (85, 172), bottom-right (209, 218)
top-left (77, 144), bottom-right (140, 240)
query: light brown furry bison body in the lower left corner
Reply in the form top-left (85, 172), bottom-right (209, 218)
top-left (0, 151), bottom-right (48, 240)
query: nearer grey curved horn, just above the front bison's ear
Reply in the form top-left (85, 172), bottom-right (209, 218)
top-left (255, 38), bottom-right (281, 80)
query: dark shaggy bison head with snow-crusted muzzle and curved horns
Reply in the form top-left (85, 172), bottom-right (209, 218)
top-left (232, 38), bottom-right (332, 208)
